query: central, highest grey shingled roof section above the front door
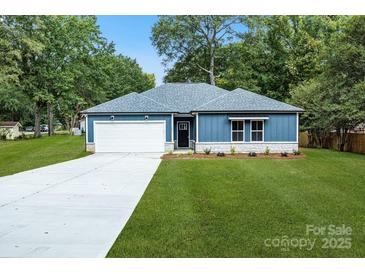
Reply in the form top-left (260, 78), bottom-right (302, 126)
top-left (141, 83), bottom-right (229, 113)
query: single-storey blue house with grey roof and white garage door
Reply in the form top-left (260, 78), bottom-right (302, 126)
top-left (83, 83), bottom-right (303, 152)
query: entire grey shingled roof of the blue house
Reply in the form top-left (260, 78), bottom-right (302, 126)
top-left (83, 83), bottom-right (303, 113)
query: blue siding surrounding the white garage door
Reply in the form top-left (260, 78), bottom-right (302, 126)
top-left (87, 114), bottom-right (171, 143)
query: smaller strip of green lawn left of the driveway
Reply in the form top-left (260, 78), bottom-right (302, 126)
top-left (0, 135), bottom-right (89, 176)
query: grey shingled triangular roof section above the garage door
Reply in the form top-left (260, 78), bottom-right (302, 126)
top-left (83, 92), bottom-right (174, 113)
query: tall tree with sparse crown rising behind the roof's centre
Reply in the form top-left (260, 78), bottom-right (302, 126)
top-left (151, 15), bottom-right (242, 85)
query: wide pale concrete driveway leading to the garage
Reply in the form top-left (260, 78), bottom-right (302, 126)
top-left (0, 153), bottom-right (161, 257)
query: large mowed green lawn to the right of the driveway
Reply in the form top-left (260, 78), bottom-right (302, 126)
top-left (108, 149), bottom-right (365, 257)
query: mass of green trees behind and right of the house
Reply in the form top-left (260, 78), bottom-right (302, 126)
top-left (152, 16), bottom-right (365, 150)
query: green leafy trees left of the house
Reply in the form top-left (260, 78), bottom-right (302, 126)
top-left (0, 16), bottom-right (155, 134)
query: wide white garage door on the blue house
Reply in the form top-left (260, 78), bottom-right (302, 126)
top-left (94, 121), bottom-right (166, 152)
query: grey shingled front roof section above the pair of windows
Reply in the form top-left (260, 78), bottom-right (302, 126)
top-left (194, 88), bottom-right (303, 112)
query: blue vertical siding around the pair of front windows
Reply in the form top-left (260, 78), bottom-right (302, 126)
top-left (199, 113), bottom-right (297, 142)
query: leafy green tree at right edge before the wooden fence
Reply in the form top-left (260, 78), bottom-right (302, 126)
top-left (291, 16), bottom-right (365, 150)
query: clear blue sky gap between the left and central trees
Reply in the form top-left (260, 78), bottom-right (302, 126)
top-left (97, 16), bottom-right (164, 85)
